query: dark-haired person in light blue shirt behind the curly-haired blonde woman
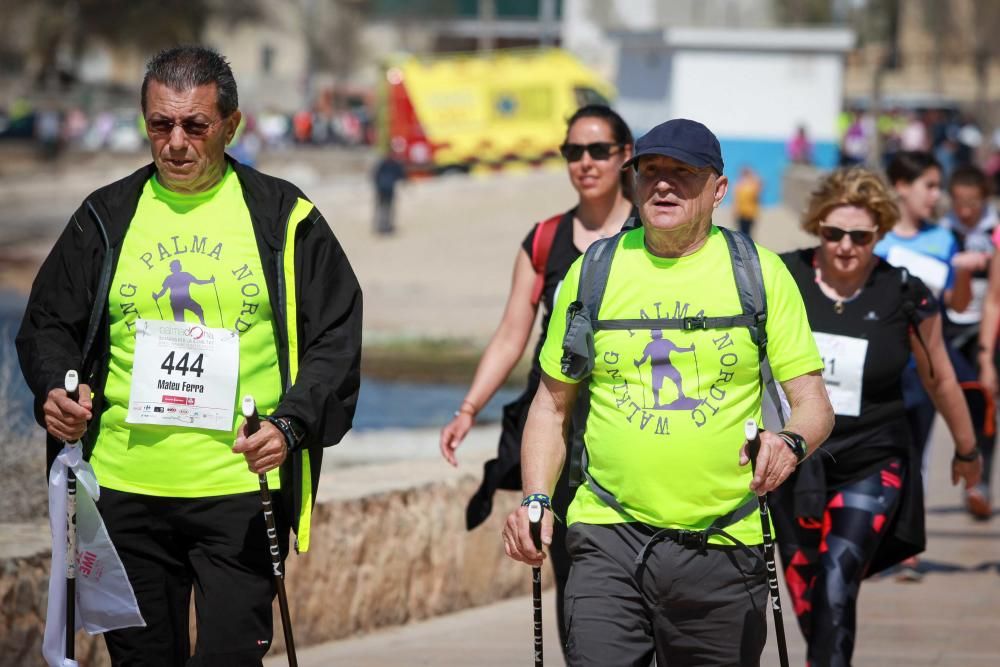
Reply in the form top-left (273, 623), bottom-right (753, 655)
top-left (875, 151), bottom-right (972, 582)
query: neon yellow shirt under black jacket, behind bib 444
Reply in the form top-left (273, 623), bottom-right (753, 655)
top-left (91, 168), bottom-right (281, 498)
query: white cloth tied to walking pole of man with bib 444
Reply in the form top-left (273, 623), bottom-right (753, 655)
top-left (42, 445), bottom-right (146, 667)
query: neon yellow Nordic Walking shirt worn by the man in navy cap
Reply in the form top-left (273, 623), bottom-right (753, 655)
top-left (540, 227), bottom-right (823, 544)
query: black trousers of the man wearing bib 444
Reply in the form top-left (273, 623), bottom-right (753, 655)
top-left (98, 489), bottom-right (288, 667)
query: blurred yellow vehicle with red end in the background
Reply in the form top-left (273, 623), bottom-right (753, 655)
top-left (377, 48), bottom-right (614, 173)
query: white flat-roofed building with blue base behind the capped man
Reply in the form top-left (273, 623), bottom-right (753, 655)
top-left (614, 28), bottom-right (854, 204)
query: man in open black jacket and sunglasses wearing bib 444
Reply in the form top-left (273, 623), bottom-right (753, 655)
top-left (17, 47), bottom-right (361, 667)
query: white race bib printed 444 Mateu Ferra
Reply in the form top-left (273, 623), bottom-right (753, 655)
top-left (125, 319), bottom-right (240, 431)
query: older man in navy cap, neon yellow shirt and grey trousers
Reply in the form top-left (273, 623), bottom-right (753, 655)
top-left (503, 119), bottom-right (833, 667)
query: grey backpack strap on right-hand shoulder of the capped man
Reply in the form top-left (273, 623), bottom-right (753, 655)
top-left (719, 227), bottom-right (785, 430)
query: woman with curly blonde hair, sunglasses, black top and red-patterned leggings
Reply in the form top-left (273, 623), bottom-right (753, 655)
top-left (772, 167), bottom-right (981, 667)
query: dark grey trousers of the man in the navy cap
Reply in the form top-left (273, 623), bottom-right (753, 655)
top-left (565, 523), bottom-right (768, 667)
